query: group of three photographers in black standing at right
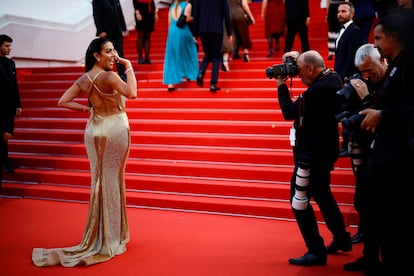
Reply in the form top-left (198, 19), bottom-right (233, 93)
top-left (266, 3), bottom-right (414, 275)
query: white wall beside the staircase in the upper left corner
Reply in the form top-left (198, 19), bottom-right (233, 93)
top-left (0, 0), bottom-right (135, 67)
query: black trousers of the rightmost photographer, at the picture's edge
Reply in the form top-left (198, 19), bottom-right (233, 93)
top-left (364, 158), bottom-right (414, 275)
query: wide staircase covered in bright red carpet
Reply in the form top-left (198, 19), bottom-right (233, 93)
top-left (2, 1), bottom-right (358, 224)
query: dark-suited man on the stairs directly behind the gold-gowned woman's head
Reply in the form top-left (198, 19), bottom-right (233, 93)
top-left (92, 0), bottom-right (128, 80)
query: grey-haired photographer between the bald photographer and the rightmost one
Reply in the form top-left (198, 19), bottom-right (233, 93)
top-left (337, 44), bottom-right (387, 271)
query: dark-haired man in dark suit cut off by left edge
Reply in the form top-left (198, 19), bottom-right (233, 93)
top-left (0, 34), bottom-right (22, 189)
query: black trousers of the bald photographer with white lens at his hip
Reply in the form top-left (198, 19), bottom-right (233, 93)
top-left (290, 164), bottom-right (349, 256)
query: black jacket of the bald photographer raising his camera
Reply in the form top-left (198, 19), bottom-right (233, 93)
top-left (277, 69), bottom-right (342, 169)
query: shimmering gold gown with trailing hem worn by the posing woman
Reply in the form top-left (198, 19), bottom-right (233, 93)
top-left (32, 72), bottom-right (130, 267)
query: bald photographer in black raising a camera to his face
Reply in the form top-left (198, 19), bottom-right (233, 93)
top-left (274, 50), bottom-right (352, 266)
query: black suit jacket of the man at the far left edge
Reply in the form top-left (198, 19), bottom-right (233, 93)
top-left (0, 57), bottom-right (21, 134)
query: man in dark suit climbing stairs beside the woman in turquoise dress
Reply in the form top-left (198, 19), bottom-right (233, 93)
top-left (193, 0), bottom-right (233, 92)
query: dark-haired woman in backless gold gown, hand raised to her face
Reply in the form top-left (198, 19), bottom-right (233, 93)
top-left (32, 38), bottom-right (137, 267)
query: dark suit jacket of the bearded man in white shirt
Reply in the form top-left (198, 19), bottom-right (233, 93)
top-left (334, 23), bottom-right (362, 80)
